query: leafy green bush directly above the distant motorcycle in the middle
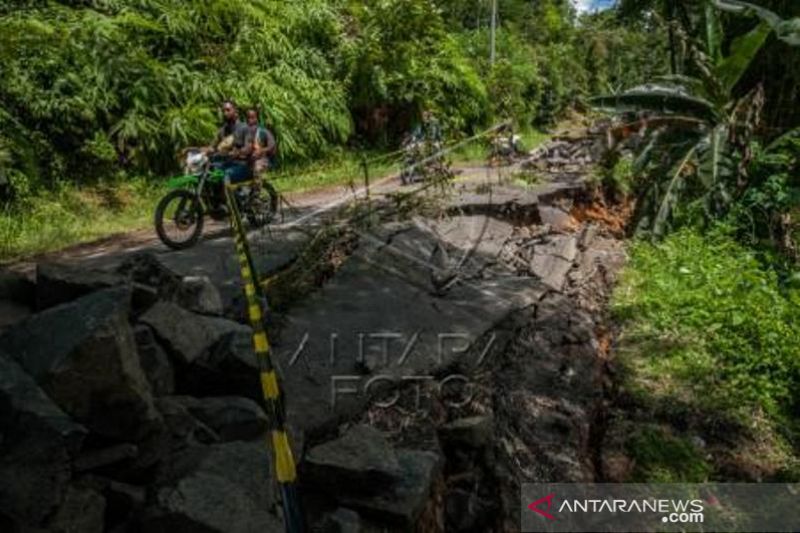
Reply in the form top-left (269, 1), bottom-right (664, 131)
top-left (343, 0), bottom-right (488, 139)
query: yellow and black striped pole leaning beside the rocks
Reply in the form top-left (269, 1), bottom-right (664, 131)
top-left (225, 184), bottom-right (305, 533)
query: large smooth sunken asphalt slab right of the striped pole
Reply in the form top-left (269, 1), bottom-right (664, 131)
top-left (275, 223), bottom-right (547, 431)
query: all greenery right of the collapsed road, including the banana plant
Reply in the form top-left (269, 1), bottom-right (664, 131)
top-left (593, 0), bottom-right (800, 482)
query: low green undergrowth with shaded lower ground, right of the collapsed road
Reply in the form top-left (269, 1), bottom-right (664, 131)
top-left (612, 229), bottom-right (800, 481)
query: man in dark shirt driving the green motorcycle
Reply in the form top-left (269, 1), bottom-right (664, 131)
top-left (205, 100), bottom-right (252, 183)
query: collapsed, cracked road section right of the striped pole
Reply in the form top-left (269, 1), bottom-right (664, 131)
top-left (275, 164), bottom-right (624, 531)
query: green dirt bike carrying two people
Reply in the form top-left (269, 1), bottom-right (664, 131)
top-left (155, 149), bottom-right (278, 250)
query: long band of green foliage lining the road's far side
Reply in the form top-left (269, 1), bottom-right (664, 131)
top-left (0, 0), bottom-right (666, 258)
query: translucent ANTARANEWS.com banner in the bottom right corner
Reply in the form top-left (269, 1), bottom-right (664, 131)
top-left (520, 483), bottom-right (800, 532)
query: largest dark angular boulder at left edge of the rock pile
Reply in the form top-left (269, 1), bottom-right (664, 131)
top-left (0, 287), bottom-right (161, 442)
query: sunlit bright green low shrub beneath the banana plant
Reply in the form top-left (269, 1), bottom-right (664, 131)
top-left (613, 229), bottom-right (800, 417)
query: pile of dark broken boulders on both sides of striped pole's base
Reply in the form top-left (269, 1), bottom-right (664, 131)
top-left (0, 255), bottom-right (450, 533)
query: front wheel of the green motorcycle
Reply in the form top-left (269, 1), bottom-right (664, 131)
top-left (155, 189), bottom-right (203, 250)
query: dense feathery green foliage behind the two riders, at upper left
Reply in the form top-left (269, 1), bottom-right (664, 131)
top-left (0, 0), bottom-right (351, 187)
